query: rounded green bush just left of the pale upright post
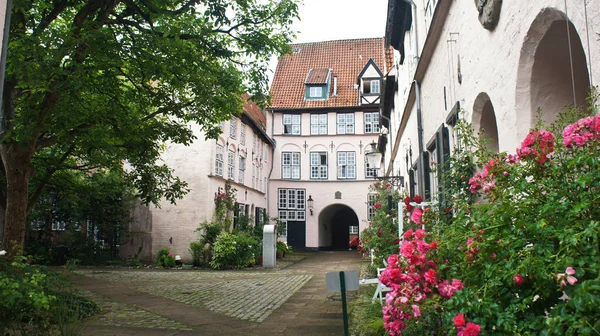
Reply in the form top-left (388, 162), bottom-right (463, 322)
top-left (210, 231), bottom-right (259, 269)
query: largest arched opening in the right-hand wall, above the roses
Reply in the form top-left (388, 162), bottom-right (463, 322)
top-left (515, 8), bottom-right (590, 139)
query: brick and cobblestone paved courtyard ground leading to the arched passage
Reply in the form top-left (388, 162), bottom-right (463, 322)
top-left (73, 251), bottom-right (361, 336)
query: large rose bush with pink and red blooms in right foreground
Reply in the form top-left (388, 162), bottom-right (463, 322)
top-left (362, 104), bottom-right (600, 335)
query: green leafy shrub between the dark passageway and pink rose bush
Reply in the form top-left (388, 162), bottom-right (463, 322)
top-left (359, 182), bottom-right (401, 263)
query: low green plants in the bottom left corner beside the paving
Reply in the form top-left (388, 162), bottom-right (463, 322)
top-left (0, 256), bottom-right (100, 335)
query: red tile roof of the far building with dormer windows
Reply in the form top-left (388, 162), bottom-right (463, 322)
top-left (269, 37), bottom-right (393, 109)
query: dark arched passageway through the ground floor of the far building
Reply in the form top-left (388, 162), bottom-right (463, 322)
top-left (319, 204), bottom-right (358, 250)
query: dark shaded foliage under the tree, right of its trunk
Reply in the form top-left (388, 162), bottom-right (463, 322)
top-left (25, 170), bottom-right (133, 265)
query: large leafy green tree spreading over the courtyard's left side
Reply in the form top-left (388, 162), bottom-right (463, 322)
top-left (0, 0), bottom-right (297, 254)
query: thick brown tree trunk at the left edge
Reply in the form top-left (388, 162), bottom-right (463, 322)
top-left (0, 143), bottom-right (34, 256)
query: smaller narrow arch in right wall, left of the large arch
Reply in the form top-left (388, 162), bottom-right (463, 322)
top-left (471, 92), bottom-right (500, 153)
